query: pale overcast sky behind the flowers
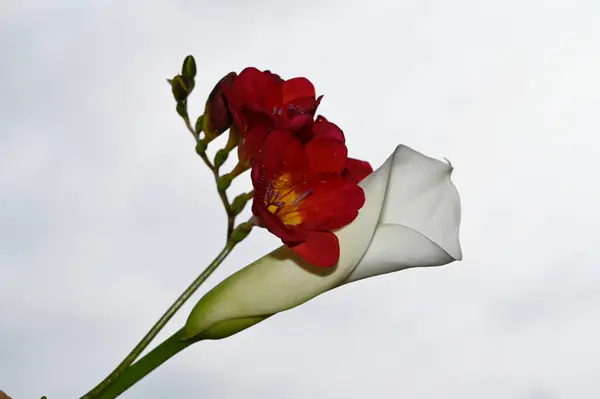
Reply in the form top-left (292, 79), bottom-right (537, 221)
top-left (0, 0), bottom-right (600, 399)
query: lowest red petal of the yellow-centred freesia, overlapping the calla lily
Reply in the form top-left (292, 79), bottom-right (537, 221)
top-left (290, 231), bottom-right (340, 267)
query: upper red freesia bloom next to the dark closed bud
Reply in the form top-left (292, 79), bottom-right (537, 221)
top-left (225, 67), bottom-right (321, 165)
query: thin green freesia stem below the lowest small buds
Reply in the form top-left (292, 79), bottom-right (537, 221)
top-left (81, 241), bottom-right (237, 399)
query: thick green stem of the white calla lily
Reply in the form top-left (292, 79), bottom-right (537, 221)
top-left (98, 328), bottom-right (197, 399)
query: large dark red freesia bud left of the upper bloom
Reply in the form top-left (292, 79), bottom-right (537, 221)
top-left (202, 72), bottom-right (237, 140)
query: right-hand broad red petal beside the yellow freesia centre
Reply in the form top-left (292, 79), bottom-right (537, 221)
top-left (297, 175), bottom-right (365, 230)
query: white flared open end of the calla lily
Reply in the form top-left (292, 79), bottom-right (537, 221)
top-left (346, 146), bottom-right (462, 282)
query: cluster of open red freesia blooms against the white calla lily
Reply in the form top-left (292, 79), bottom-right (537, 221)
top-left (221, 68), bottom-right (373, 267)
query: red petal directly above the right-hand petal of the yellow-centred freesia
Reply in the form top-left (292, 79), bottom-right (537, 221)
top-left (304, 139), bottom-right (348, 174)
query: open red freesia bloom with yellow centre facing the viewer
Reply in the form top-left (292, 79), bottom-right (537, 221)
top-left (252, 130), bottom-right (365, 267)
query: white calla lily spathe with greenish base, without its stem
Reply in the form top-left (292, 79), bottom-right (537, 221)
top-left (184, 145), bottom-right (462, 339)
